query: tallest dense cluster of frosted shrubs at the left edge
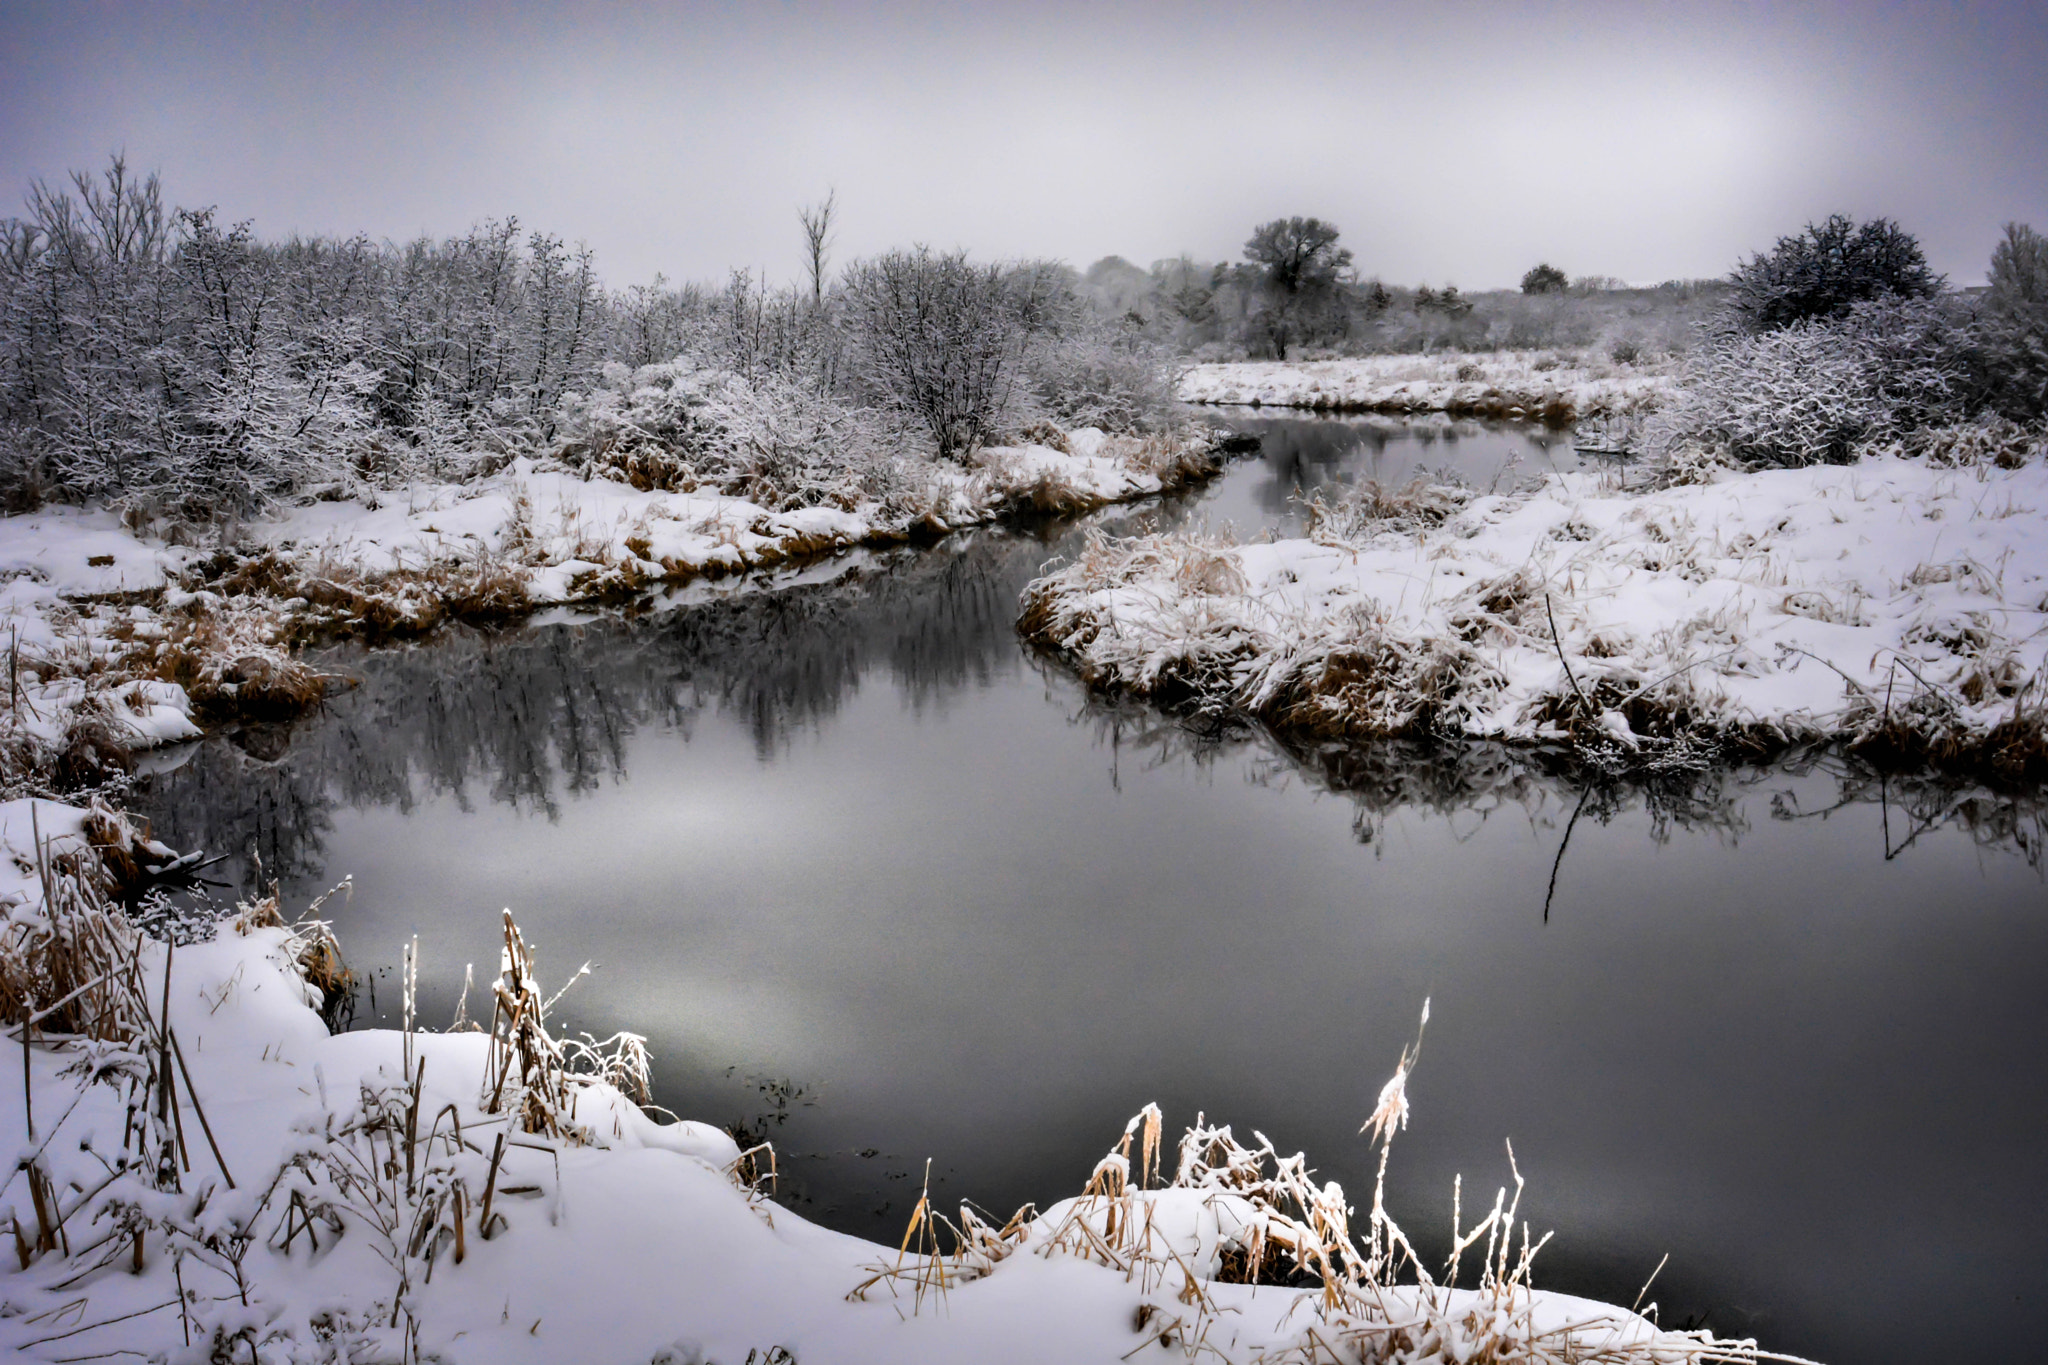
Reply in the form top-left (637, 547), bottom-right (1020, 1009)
top-left (0, 158), bottom-right (626, 522)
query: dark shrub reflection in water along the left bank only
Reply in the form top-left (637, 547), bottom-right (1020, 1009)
top-left (137, 520), bottom-right (1073, 876)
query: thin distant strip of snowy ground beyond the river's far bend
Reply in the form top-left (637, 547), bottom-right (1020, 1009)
top-left (1180, 350), bottom-right (1677, 422)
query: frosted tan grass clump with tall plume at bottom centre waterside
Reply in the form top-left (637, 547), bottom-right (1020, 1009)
top-left (848, 1003), bottom-right (1794, 1365)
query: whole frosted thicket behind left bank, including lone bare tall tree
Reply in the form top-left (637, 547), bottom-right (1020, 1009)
top-left (0, 158), bottom-right (1167, 522)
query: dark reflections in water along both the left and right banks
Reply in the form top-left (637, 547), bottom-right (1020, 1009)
top-left (135, 508), bottom-right (2044, 896)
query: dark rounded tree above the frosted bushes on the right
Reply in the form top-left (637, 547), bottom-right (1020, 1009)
top-left (1729, 213), bottom-right (1942, 332)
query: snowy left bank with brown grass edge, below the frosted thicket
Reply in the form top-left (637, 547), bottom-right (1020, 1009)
top-left (0, 428), bottom-right (1219, 786)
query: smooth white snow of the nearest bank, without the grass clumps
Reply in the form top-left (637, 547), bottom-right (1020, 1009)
top-left (0, 800), bottom-right (1744, 1365)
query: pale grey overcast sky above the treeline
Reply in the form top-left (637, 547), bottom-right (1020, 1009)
top-left (0, 0), bottom-right (2048, 291)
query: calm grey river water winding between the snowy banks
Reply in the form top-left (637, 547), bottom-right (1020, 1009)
top-left (136, 417), bottom-right (2048, 1361)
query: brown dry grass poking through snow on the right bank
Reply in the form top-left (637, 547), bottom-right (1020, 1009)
top-left (1018, 474), bottom-right (2048, 788)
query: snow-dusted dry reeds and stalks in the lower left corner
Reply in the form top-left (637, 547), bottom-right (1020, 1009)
top-left (0, 871), bottom-right (704, 1361)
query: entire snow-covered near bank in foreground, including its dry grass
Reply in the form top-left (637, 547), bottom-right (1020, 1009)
top-left (0, 800), bottom-right (1751, 1365)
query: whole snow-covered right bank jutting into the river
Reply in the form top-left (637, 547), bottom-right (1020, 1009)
top-left (1024, 456), bottom-right (2048, 778)
